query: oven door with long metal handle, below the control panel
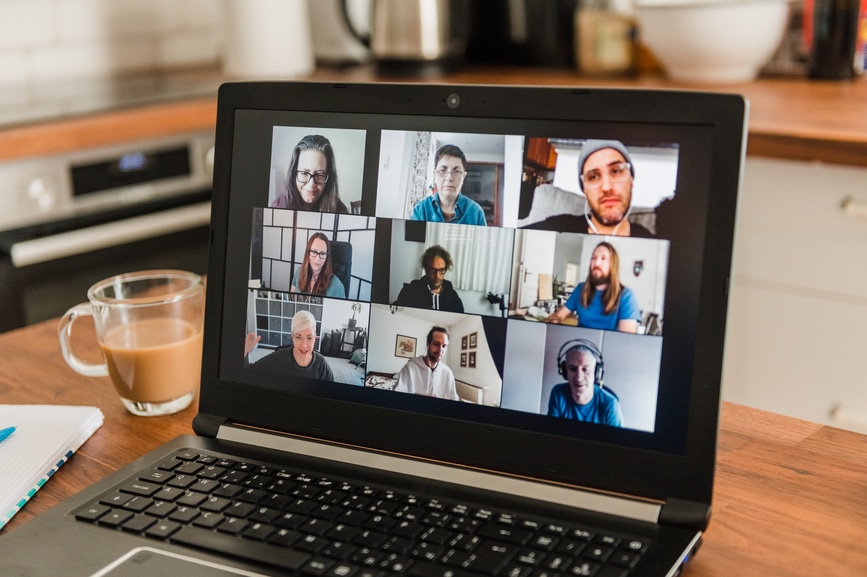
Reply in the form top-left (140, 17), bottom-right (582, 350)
top-left (0, 198), bottom-right (210, 332)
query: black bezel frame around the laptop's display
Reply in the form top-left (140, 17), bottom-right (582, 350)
top-left (197, 83), bottom-right (747, 520)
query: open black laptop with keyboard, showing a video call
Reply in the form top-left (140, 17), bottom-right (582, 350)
top-left (0, 82), bottom-right (748, 577)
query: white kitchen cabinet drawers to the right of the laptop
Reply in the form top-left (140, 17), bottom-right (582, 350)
top-left (723, 158), bottom-right (867, 431)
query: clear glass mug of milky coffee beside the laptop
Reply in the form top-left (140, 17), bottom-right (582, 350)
top-left (57, 270), bottom-right (205, 416)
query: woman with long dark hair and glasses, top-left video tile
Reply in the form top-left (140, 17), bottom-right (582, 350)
top-left (271, 134), bottom-right (349, 214)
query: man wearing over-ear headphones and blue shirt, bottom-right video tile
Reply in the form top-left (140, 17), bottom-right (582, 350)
top-left (548, 339), bottom-right (623, 427)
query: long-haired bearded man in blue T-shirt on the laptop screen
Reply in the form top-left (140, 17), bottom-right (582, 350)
top-left (545, 241), bottom-right (641, 333)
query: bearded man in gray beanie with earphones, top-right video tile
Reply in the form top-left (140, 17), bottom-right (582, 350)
top-left (527, 140), bottom-right (653, 238)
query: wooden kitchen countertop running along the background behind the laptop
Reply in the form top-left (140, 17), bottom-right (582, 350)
top-left (0, 66), bottom-right (867, 166)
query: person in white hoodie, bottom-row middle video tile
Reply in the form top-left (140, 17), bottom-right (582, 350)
top-left (396, 327), bottom-right (460, 401)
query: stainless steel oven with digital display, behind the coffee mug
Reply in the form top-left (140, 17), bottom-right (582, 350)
top-left (0, 130), bottom-right (214, 332)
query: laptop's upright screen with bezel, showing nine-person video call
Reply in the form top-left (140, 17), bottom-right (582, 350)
top-left (202, 84), bottom-right (743, 506)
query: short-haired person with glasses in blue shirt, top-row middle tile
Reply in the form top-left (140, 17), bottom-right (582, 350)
top-left (410, 144), bottom-right (487, 226)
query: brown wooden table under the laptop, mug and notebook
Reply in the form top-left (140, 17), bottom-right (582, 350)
top-left (0, 321), bottom-right (867, 577)
